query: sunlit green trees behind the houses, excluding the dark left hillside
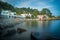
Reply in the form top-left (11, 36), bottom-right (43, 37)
top-left (15, 7), bottom-right (53, 18)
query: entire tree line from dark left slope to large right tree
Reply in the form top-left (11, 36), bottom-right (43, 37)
top-left (0, 1), bottom-right (58, 18)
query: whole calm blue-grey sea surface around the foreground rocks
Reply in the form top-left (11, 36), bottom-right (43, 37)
top-left (0, 20), bottom-right (60, 40)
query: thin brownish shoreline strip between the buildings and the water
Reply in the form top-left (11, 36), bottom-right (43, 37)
top-left (2, 18), bottom-right (60, 22)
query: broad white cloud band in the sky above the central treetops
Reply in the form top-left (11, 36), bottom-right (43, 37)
top-left (16, 0), bottom-right (53, 10)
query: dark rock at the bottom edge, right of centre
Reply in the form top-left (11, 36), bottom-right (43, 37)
top-left (31, 32), bottom-right (57, 40)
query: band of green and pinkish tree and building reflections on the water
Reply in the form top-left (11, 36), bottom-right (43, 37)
top-left (25, 20), bottom-right (50, 28)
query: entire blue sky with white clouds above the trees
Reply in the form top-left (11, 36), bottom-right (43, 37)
top-left (2, 0), bottom-right (60, 16)
